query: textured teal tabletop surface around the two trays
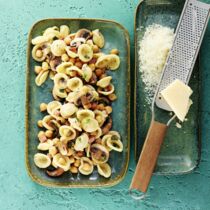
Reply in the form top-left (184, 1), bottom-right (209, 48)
top-left (0, 0), bottom-right (210, 210)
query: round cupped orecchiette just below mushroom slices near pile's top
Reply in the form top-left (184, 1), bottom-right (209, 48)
top-left (78, 44), bottom-right (93, 62)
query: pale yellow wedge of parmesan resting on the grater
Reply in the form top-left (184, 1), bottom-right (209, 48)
top-left (161, 79), bottom-right (193, 122)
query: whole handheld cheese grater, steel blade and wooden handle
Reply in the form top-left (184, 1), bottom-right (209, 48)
top-left (130, 0), bottom-right (210, 198)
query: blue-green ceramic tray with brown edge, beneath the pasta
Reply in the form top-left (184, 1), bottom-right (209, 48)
top-left (25, 19), bottom-right (130, 187)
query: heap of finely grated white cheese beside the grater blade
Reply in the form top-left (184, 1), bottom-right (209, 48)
top-left (139, 24), bottom-right (174, 104)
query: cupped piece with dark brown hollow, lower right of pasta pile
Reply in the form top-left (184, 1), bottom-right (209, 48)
top-left (90, 144), bottom-right (109, 164)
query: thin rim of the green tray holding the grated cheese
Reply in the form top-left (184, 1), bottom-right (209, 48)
top-left (133, 0), bottom-right (202, 175)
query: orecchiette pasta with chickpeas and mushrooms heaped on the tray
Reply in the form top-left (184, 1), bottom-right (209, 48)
top-left (31, 25), bottom-right (123, 178)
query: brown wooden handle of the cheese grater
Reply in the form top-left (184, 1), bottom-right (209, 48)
top-left (130, 120), bottom-right (168, 193)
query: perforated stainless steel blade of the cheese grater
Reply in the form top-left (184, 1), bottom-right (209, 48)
top-left (154, 0), bottom-right (210, 111)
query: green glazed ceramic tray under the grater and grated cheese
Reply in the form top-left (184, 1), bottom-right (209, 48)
top-left (134, 0), bottom-right (200, 174)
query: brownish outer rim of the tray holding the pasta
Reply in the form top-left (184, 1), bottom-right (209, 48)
top-left (25, 18), bottom-right (131, 188)
